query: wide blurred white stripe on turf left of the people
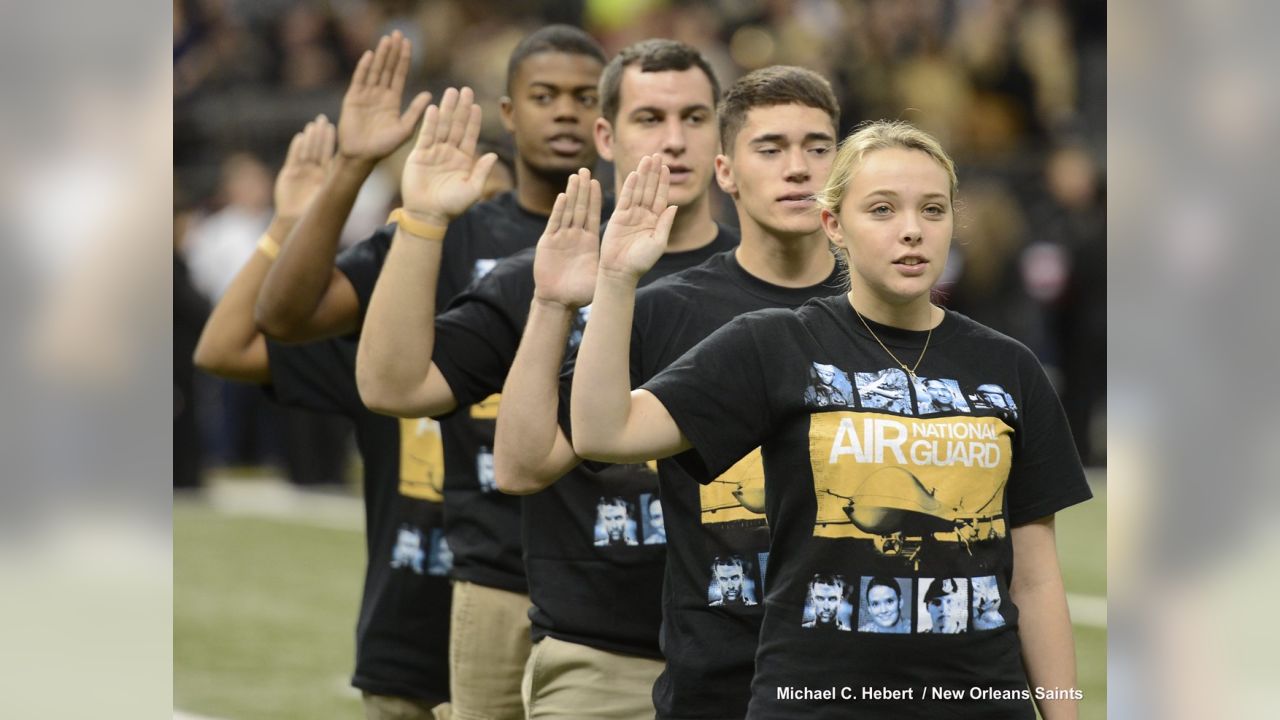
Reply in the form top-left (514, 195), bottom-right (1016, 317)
top-left (205, 479), bottom-right (365, 533)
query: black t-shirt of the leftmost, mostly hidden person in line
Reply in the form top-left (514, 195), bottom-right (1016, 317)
top-left (268, 338), bottom-right (452, 702)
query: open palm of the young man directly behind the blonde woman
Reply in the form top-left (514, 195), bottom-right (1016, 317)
top-left (534, 168), bottom-right (600, 307)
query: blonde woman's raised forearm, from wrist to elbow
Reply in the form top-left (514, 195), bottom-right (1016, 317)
top-left (570, 273), bottom-right (636, 460)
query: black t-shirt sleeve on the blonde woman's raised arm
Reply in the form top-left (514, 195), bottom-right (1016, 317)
top-left (641, 315), bottom-right (773, 482)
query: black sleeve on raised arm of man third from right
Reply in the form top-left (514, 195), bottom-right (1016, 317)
top-left (431, 256), bottom-right (534, 407)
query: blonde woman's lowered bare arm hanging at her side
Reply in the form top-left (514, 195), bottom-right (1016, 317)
top-left (1009, 515), bottom-right (1079, 720)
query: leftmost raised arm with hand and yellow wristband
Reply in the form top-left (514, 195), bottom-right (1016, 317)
top-left (196, 115), bottom-right (334, 383)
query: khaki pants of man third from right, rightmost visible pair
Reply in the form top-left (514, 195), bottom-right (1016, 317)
top-left (521, 638), bottom-right (663, 720)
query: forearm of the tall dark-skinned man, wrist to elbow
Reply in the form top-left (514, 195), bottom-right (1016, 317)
top-left (256, 155), bottom-right (374, 341)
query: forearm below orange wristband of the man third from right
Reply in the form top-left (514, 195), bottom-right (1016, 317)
top-left (356, 228), bottom-right (442, 416)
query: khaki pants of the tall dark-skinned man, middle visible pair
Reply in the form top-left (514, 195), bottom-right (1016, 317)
top-left (449, 580), bottom-right (530, 720)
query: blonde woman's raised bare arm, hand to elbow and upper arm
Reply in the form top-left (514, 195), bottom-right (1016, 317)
top-left (570, 155), bottom-right (689, 462)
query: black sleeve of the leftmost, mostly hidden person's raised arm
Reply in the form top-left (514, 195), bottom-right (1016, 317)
top-left (264, 338), bottom-right (364, 415)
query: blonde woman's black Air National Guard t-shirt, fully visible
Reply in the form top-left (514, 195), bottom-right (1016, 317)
top-left (644, 296), bottom-right (1091, 720)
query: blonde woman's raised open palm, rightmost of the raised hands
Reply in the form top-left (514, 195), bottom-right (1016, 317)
top-left (600, 155), bottom-right (676, 281)
